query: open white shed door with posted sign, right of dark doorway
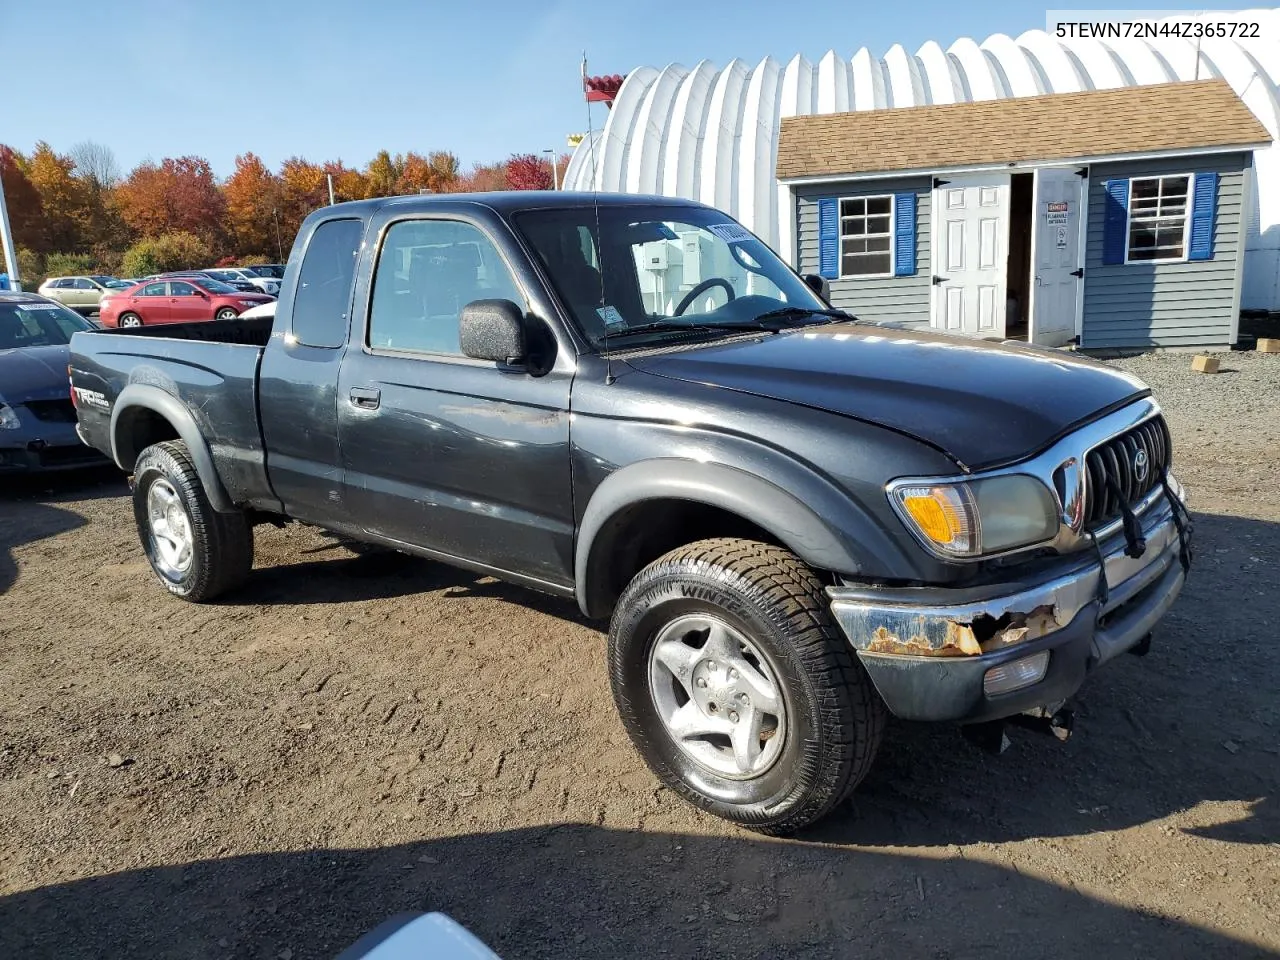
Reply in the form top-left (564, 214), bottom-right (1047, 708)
top-left (1029, 168), bottom-right (1085, 347)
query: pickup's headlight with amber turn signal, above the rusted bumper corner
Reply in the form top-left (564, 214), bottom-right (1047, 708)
top-left (888, 474), bottom-right (1060, 558)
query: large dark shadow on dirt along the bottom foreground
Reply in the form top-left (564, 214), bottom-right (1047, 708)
top-left (0, 826), bottom-right (1268, 960)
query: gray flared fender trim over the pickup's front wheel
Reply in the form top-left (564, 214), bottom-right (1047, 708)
top-left (575, 458), bottom-right (910, 617)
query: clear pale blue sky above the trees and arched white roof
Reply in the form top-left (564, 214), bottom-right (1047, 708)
top-left (0, 0), bottom-right (1240, 175)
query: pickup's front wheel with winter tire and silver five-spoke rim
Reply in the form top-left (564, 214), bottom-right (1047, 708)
top-left (609, 539), bottom-right (886, 835)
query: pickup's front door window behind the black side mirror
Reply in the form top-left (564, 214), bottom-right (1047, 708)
top-left (369, 220), bottom-right (529, 356)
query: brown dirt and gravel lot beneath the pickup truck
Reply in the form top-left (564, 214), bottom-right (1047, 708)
top-left (0, 355), bottom-right (1280, 960)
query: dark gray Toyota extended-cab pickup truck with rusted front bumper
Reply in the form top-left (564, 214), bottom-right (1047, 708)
top-left (72, 193), bottom-right (1190, 833)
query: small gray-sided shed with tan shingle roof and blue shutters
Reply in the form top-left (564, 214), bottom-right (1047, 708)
top-left (777, 79), bottom-right (1270, 348)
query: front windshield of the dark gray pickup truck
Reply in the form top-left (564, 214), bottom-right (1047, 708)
top-left (515, 205), bottom-right (827, 347)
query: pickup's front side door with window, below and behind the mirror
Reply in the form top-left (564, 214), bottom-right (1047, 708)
top-left (338, 210), bottom-right (573, 588)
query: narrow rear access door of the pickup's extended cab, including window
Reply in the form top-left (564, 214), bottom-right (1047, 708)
top-left (259, 219), bottom-right (365, 529)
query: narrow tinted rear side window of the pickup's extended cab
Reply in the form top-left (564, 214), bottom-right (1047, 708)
top-left (292, 220), bottom-right (365, 347)
